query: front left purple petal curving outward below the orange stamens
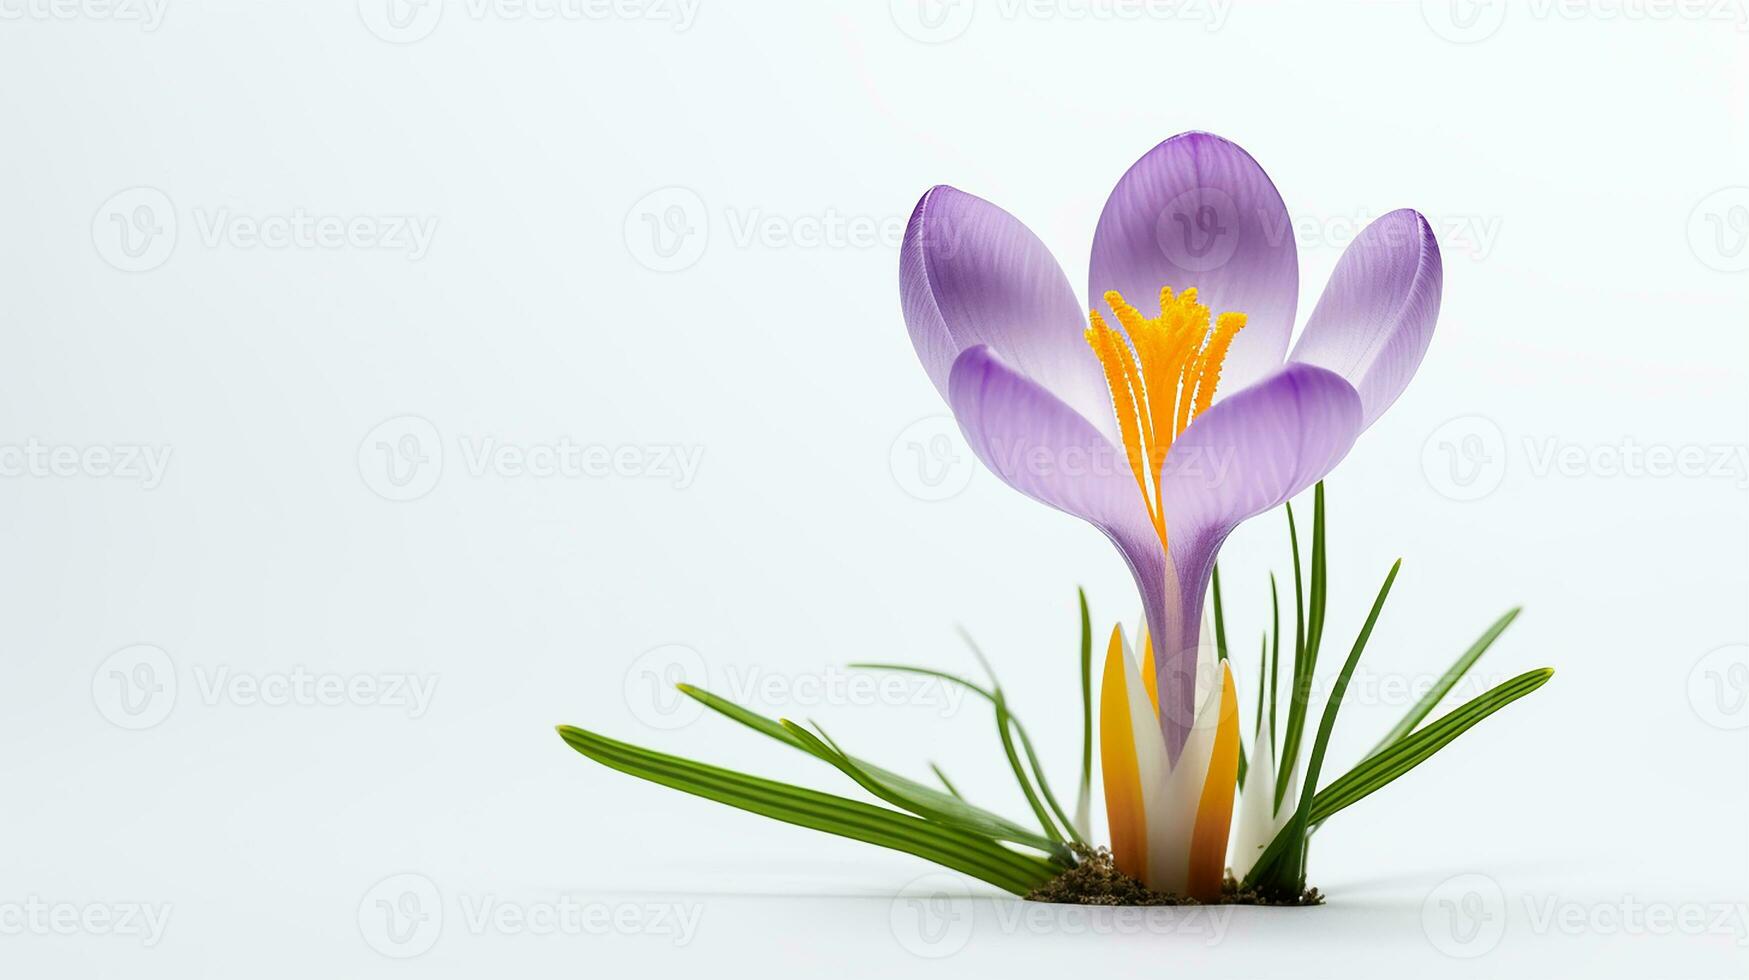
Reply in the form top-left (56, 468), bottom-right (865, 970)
top-left (948, 347), bottom-right (1175, 654)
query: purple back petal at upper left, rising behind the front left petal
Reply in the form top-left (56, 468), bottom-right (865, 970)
top-left (899, 186), bottom-right (1116, 436)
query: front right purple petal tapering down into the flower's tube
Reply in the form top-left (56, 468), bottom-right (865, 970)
top-left (1154, 364), bottom-right (1361, 754)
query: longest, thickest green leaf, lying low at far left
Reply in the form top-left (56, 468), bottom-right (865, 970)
top-left (558, 725), bottom-right (1063, 894)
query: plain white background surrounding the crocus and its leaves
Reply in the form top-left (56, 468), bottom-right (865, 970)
top-left (0, 0), bottom-right (1749, 977)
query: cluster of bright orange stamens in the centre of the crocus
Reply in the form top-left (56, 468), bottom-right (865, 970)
top-left (1086, 285), bottom-right (1245, 548)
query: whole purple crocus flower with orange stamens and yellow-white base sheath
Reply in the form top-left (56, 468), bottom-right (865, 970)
top-left (899, 133), bottom-right (1441, 896)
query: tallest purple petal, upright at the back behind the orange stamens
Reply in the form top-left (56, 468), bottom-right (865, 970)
top-left (1088, 133), bottom-right (1300, 392)
